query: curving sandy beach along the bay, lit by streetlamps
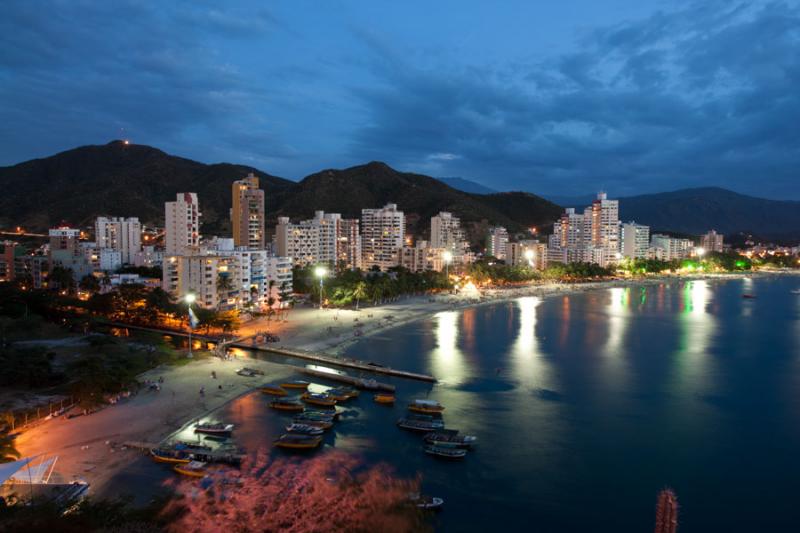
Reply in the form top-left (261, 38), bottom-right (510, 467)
top-left (17, 273), bottom-right (784, 495)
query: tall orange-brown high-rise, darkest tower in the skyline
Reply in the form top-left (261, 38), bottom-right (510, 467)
top-left (231, 172), bottom-right (265, 250)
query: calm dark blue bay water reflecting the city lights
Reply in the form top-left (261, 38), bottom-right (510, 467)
top-left (120, 276), bottom-right (800, 533)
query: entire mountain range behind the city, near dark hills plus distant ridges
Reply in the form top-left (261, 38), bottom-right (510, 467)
top-left (0, 141), bottom-right (800, 241)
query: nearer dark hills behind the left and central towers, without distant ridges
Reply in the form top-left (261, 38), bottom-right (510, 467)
top-left (0, 141), bottom-right (561, 240)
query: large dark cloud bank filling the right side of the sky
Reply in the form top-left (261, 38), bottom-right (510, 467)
top-left (352, 2), bottom-right (800, 198)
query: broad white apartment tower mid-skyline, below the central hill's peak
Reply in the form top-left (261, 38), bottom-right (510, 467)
top-left (361, 204), bottom-right (406, 270)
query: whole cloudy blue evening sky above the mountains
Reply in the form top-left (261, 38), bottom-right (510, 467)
top-left (0, 0), bottom-right (800, 199)
